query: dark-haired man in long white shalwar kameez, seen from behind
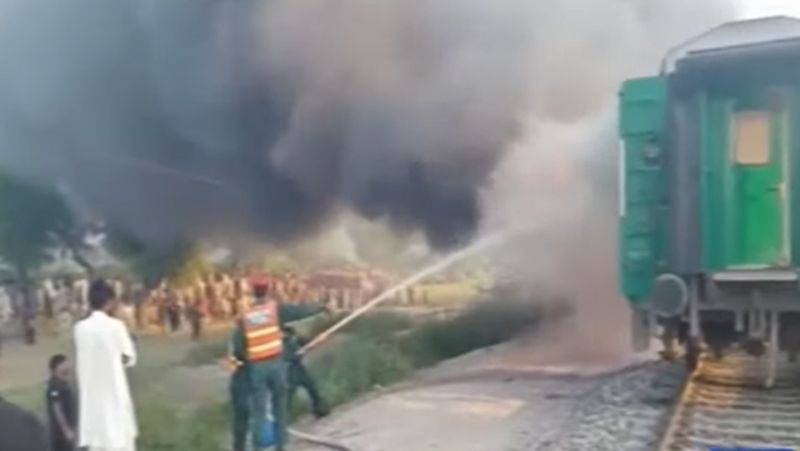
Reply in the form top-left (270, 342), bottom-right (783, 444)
top-left (75, 281), bottom-right (138, 451)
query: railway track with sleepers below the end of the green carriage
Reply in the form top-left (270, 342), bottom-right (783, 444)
top-left (659, 355), bottom-right (800, 451)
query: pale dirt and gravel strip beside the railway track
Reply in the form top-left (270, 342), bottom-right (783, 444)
top-left (290, 322), bottom-right (680, 451)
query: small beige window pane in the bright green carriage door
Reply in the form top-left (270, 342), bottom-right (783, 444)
top-left (732, 111), bottom-right (770, 165)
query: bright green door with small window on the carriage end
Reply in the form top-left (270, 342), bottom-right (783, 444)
top-left (726, 97), bottom-right (791, 269)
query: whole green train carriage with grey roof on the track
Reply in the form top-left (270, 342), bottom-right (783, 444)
top-left (619, 17), bottom-right (800, 382)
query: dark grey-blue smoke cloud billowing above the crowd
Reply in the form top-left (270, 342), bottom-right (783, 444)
top-left (0, 0), bottom-right (527, 251)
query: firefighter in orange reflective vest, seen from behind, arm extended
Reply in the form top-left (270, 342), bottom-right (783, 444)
top-left (231, 278), bottom-right (324, 451)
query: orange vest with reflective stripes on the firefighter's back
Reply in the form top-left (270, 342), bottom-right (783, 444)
top-left (242, 301), bottom-right (283, 362)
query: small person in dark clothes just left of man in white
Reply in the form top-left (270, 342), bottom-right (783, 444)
top-left (47, 354), bottom-right (77, 451)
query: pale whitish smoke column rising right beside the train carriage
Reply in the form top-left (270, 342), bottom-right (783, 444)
top-left (483, 0), bottom-right (736, 361)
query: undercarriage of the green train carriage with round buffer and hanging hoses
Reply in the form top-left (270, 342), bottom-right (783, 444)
top-left (634, 272), bottom-right (800, 387)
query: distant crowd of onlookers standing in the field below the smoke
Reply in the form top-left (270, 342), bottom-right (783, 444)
top-left (0, 271), bottom-right (390, 341)
